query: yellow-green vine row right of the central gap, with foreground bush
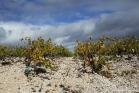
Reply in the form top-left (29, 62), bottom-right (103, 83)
top-left (74, 36), bottom-right (139, 72)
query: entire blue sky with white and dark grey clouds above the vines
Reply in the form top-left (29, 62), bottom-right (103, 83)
top-left (0, 0), bottom-right (139, 51)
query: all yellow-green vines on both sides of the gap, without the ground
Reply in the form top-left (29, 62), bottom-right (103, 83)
top-left (0, 36), bottom-right (139, 72)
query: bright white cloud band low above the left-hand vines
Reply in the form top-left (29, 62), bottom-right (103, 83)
top-left (0, 20), bottom-right (94, 49)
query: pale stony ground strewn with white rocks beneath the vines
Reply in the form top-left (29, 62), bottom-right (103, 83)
top-left (0, 56), bottom-right (139, 93)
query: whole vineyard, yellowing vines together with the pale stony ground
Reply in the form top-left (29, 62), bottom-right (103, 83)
top-left (0, 36), bottom-right (139, 93)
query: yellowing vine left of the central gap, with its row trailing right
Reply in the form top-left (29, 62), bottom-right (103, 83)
top-left (21, 37), bottom-right (72, 69)
